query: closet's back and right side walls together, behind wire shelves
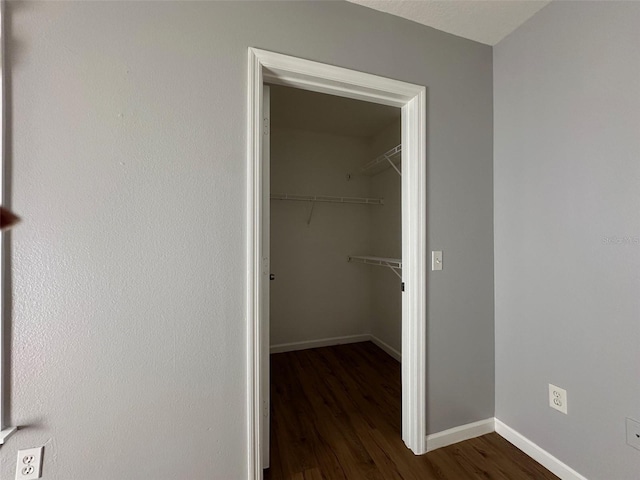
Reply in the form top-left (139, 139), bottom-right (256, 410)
top-left (270, 88), bottom-right (401, 351)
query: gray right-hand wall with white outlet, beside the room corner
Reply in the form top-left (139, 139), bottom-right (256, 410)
top-left (494, 2), bottom-right (640, 480)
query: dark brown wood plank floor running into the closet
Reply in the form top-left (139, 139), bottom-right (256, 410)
top-left (265, 342), bottom-right (558, 480)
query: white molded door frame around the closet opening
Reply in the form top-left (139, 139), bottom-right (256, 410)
top-left (246, 48), bottom-right (427, 480)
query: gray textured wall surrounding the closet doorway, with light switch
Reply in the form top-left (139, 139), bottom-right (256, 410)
top-left (0, 1), bottom-right (496, 480)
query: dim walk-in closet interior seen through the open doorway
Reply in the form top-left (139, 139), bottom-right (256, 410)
top-left (263, 85), bottom-right (405, 480)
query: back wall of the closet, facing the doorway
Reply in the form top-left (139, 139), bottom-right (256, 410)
top-left (269, 128), bottom-right (372, 345)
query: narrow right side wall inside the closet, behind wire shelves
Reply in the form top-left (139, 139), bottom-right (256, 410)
top-left (369, 121), bottom-right (402, 352)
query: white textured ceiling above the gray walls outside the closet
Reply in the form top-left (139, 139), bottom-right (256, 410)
top-left (347, 0), bottom-right (550, 45)
